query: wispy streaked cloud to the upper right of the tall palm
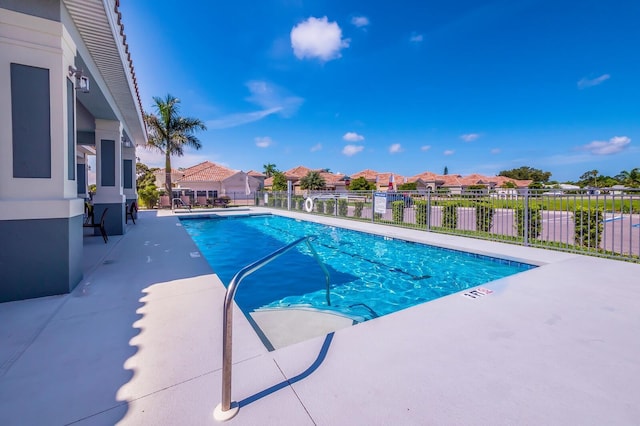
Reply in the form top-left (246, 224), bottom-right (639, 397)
top-left (206, 80), bottom-right (304, 130)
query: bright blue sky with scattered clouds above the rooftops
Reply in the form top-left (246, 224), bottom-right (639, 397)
top-left (120, 0), bottom-right (640, 181)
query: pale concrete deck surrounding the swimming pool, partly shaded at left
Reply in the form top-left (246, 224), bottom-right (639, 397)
top-left (0, 208), bottom-right (640, 425)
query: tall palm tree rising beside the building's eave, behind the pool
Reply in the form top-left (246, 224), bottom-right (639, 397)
top-left (144, 94), bottom-right (207, 197)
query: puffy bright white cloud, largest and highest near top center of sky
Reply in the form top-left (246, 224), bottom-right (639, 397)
top-left (291, 16), bottom-right (349, 61)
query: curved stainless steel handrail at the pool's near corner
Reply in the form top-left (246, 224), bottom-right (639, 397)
top-left (214, 236), bottom-right (331, 421)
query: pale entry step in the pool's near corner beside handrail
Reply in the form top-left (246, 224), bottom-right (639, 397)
top-left (249, 306), bottom-right (366, 349)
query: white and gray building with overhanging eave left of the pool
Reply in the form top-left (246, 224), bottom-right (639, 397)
top-left (0, 0), bottom-right (147, 302)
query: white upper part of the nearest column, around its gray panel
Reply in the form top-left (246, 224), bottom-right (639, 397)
top-left (0, 9), bottom-right (83, 220)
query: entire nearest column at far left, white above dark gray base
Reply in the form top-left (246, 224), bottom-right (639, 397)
top-left (0, 9), bottom-right (83, 302)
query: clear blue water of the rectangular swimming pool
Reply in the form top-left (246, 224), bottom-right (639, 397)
top-left (182, 215), bottom-right (533, 320)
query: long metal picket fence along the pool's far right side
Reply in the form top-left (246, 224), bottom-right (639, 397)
top-left (255, 189), bottom-right (640, 262)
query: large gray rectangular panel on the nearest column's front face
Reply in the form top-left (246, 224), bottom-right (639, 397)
top-left (11, 64), bottom-right (51, 178)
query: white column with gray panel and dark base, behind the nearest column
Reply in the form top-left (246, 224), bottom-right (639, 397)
top-left (93, 119), bottom-right (126, 235)
